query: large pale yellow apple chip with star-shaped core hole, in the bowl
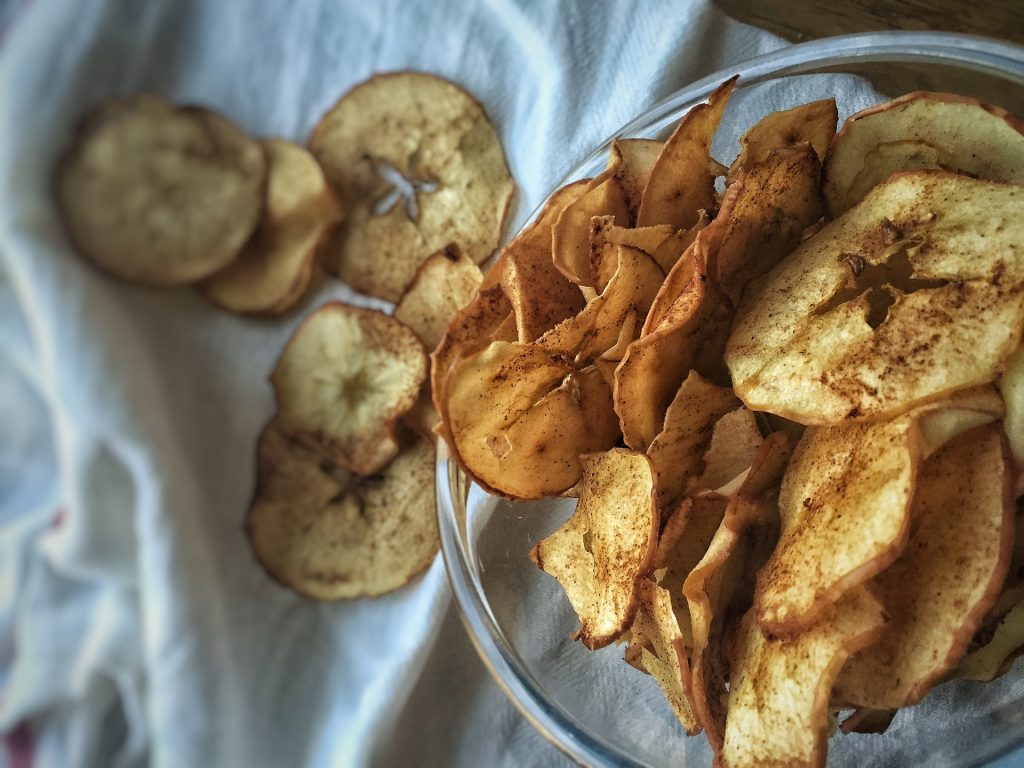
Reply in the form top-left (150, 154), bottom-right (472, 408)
top-left (725, 172), bottom-right (1024, 424)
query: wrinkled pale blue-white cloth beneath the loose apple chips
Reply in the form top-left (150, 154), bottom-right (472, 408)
top-left (0, 0), bottom-right (806, 768)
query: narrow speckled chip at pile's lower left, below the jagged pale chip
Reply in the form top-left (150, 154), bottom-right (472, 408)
top-left (627, 579), bottom-right (700, 735)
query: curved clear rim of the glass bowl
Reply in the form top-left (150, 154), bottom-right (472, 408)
top-left (436, 31), bottom-right (1024, 767)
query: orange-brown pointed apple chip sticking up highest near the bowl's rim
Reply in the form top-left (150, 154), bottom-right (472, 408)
top-left (636, 78), bottom-right (736, 229)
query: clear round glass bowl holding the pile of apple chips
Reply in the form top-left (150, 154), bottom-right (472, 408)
top-left (437, 32), bottom-right (1024, 768)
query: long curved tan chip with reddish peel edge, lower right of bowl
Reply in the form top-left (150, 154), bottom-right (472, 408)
top-left (834, 424), bottom-right (1014, 710)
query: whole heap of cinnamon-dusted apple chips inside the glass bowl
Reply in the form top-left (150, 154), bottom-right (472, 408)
top-left (431, 81), bottom-right (1024, 766)
